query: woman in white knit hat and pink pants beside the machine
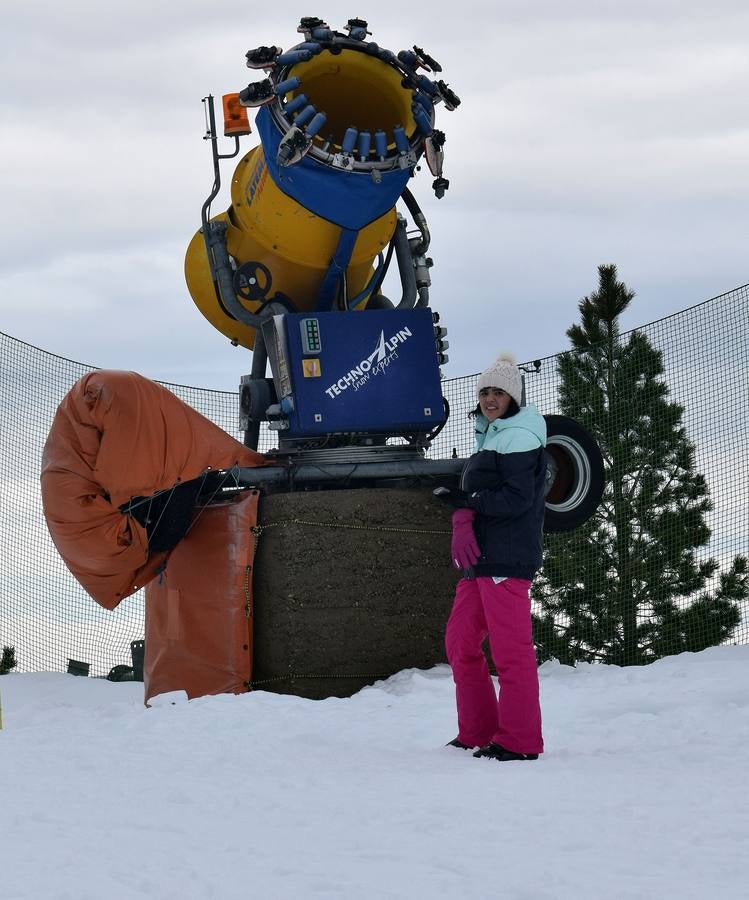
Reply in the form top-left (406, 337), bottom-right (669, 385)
top-left (438, 354), bottom-right (546, 761)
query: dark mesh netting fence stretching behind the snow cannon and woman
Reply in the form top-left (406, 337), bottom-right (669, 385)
top-left (0, 286), bottom-right (749, 676)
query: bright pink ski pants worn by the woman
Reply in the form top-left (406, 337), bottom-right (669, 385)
top-left (445, 578), bottom-right (544, 753)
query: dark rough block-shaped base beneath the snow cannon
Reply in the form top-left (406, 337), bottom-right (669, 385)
top-left (253, 488), bottom-right (459, 699)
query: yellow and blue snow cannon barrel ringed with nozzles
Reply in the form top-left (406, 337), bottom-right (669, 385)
top-left (185, 19), bottom-right (459, 348)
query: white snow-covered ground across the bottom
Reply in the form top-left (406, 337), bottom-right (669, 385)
top-left (0, 646), bottom-right (749, 900)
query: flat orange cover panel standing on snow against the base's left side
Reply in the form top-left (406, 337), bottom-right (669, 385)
top-left (143, 490), bottom-right (258, 702)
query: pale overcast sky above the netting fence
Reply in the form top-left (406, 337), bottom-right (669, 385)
top-left (0, 0), bottom-right (749, 390)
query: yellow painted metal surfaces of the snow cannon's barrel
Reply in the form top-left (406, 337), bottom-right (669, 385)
top-left (185, 44), bottom-right (416, 349)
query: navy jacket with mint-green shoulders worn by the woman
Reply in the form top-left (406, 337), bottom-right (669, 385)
top-left (460, 405), bottom-right (546, 581)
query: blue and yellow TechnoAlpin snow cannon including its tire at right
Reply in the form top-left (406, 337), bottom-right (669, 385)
top-left (185, 17), bottom-right (602, 544)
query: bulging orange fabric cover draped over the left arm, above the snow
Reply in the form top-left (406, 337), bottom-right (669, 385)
top-left (41, 371), bottom-right (266, 609)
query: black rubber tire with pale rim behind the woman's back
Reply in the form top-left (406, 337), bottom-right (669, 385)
top-left (544, 416), bottom-right (604, 533)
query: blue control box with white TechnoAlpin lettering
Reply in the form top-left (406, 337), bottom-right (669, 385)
top-left (263, 308), bottom-right (445, 438)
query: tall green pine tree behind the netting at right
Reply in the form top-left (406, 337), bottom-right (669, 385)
top-left (534, 265), bottom-right (749, 665)
